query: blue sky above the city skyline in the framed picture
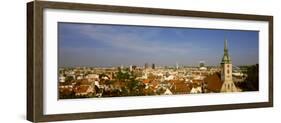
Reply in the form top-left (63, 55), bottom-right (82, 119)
top-left (58, 22), bottom-right (259, 67)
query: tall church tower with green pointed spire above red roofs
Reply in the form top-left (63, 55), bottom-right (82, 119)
top-left (221, 40), bottom-right (238, 92)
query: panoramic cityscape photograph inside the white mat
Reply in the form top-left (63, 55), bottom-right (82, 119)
top-left (58, 22), bottom-right (259, 99)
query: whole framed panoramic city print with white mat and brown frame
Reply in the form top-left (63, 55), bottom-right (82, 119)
top-left (27, 1), bottom-right (273, 122)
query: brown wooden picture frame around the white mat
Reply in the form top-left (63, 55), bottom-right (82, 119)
top-left (27, 1), bottom-right (273, 122)
